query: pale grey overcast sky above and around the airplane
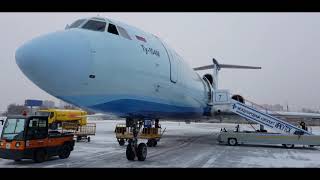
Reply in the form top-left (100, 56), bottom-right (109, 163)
top-left (0, 13), bottom-right (320, 111)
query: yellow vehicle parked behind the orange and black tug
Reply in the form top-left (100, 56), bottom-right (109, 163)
top-left (37, 109), bottom-right (87, 129)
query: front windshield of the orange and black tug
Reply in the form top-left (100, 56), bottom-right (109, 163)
top-left (2, 119), bottom-right (26, 140)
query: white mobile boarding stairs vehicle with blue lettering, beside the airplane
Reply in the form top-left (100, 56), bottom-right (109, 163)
top-left (214, 90), bottom-right (320, 148)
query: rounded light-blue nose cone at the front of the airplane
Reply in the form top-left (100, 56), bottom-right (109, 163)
top-left (15, 30), bottom-right (91, 94)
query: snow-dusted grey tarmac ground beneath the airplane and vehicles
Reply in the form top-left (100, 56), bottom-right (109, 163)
top-left (0, 120), bottom-right (320, 167)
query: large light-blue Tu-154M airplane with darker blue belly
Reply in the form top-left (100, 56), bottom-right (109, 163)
top-left (15, 17), bottom-right (320, 161)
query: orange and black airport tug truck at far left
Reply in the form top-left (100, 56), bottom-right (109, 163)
top-left (0, 116), bottom-right (75, 163)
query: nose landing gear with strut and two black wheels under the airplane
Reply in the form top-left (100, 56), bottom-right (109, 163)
top-left (126, 118), bottom-right (147, 161)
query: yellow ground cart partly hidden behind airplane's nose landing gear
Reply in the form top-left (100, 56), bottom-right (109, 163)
top-left (114, 120), bottom-right (166, 147)
